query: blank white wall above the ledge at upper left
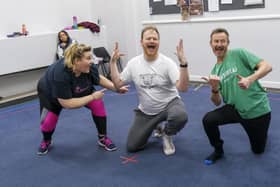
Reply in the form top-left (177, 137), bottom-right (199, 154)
top-left (0, 0), bottom-right (92, 37)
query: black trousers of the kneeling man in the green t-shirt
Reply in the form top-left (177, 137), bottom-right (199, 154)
top-left (203, 105), bottom-right (271, 154)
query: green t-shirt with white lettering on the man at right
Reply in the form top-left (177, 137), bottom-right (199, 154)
top-left (211, 49), bottom-right (271, 119)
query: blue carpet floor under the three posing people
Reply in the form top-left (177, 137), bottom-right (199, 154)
top-left (0, 87), bottom-right (280, 187)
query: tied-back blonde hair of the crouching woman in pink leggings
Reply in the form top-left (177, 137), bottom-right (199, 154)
top-left (64, 43), bottom-right (91, 69)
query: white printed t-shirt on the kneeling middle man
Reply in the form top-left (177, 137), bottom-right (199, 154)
top-left (120, 54), bottom-right (179, 115)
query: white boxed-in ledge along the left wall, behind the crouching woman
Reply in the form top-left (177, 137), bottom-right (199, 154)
top-left (0, 29), bottom-right (107, 98)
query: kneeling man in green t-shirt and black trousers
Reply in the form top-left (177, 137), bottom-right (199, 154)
top-left (203, 28), bottom-right (272, 165)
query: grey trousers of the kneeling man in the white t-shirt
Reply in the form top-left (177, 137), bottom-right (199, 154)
top-left (127, 98), bottom-right (188, 152)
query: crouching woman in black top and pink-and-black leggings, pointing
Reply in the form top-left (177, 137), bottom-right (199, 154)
top-left (38, 43), bottom-right (128, 155)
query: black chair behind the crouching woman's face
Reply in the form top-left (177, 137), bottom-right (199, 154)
top-left (93, 47), bottom-right (122, 80)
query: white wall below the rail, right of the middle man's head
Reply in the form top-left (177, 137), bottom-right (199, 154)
top-left (143, 16), bottom-right (280, 88)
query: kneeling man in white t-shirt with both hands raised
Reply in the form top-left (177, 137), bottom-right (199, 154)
top-left (110, 26), bottom-right (189, 155)
